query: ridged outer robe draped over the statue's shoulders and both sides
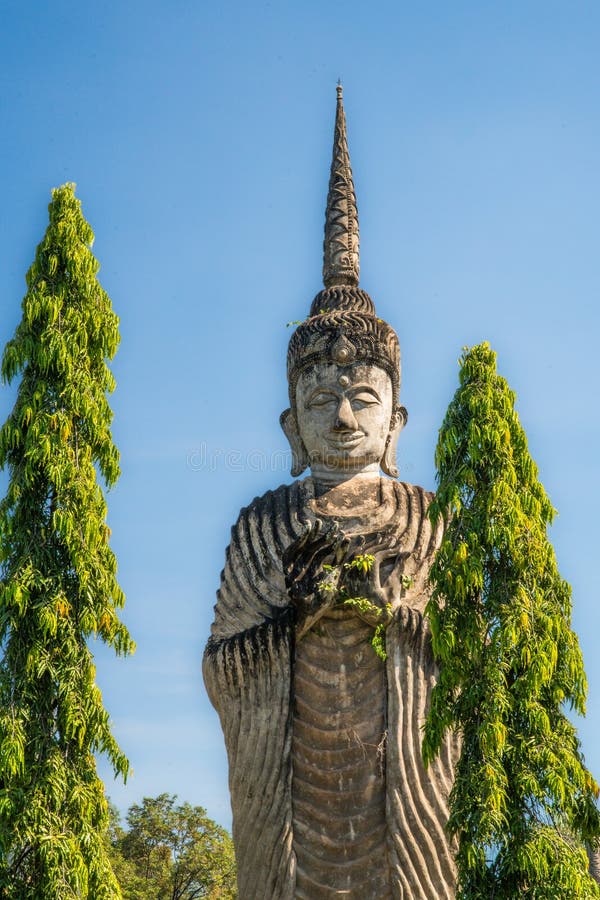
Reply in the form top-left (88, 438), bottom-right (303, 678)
top-left (203, 478), bottom-right (457, 900)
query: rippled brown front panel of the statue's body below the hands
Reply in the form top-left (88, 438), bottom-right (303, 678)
top-left (292, 610), bottom-right (391, 900)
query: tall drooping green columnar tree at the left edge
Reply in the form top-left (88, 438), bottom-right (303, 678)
top-left (0, 184), bottom-right (133, 900)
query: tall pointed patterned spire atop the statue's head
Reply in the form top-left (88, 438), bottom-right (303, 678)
top-left (323, 81), bottom-right (360, 288)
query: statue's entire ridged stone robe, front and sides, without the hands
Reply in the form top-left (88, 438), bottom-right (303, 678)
top-left (203, 478), bottom-right (458, 900)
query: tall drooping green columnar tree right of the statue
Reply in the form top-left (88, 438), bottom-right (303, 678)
top-left (423, 343), bottom-right (600, 900)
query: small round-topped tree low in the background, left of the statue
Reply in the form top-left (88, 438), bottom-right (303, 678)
top-left (110, 794), bottom-right (237, 900)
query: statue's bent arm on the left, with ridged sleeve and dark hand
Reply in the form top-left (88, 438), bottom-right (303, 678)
top-left (203, 501), bottom-right (347, 709)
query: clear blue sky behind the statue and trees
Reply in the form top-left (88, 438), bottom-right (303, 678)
top-left (0, 0), bottom-right (600, 824)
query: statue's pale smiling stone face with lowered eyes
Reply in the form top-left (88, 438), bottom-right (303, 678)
top-left (296, 363), bottom-right (394, 472)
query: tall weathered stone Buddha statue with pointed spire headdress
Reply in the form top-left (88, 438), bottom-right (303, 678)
top-left (203, 87), bottom-right (457, 900)
